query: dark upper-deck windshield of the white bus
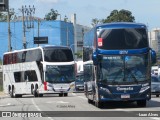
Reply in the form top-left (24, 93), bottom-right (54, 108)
top-left (44, 48), bottom-right (73, 62)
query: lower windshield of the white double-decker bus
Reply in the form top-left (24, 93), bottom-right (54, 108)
top-left (46, 65), bottom-right (75, 83)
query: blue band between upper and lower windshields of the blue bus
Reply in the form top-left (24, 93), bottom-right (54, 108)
top-left (97, 48), bottom-right (150, 55)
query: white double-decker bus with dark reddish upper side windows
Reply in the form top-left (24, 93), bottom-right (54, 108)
top-left (3, 46), bottom-right (75, 97)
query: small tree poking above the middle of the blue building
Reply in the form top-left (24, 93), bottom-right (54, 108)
top-left (44, 9), bottom-right (59, 20)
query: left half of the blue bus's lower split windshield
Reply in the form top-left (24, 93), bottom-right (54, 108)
top-left (98, 56), bottom-right (124, 82)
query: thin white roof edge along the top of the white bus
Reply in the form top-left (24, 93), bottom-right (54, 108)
top-left (4, 45), bottom-right (70, 54)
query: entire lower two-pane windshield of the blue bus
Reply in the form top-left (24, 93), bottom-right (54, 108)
top-left (98, 54), bottom-right (149, 84)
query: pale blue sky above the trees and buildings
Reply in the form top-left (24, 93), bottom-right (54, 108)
top-left (9, 0), bottom-right (160, 30)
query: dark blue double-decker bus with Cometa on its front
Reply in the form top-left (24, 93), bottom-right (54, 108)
top-left (83, 22), bottom-right (156, 107)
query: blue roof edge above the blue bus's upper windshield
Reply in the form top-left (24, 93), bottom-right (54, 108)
top-left (96, 22), bottom-right (146, 29)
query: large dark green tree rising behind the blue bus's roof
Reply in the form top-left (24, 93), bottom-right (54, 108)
top-left (103, 9), bottom-right (135, 23)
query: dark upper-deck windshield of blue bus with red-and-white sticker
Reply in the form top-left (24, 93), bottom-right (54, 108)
top-left (97, 28), bottom-right (148, 50)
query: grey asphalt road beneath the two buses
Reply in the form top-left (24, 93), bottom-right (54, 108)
top-left (0, 93), bottom-right (160, 120)
